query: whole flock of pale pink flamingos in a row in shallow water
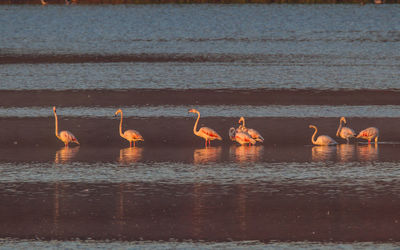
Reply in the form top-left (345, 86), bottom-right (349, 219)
top-left (53, 107), bottom-right (379, 147)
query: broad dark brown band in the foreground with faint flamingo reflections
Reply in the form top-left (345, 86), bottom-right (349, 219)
top-left (0, 182), bottom-right (400, 242)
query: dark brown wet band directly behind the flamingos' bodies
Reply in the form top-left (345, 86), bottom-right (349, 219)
top-left (0, 116), bottom-right (400, 148)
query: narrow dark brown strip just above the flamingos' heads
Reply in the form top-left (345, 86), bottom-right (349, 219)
top-left (0, 89), bottom-right (400, 107)
